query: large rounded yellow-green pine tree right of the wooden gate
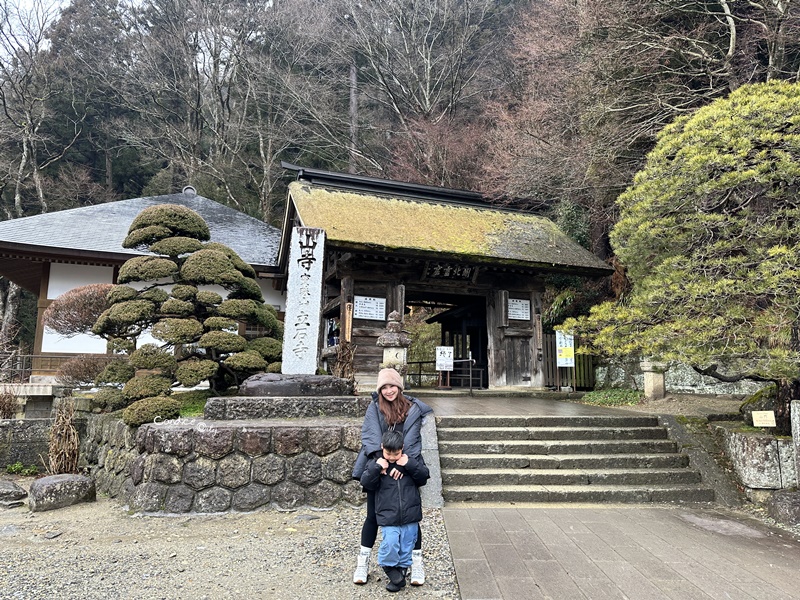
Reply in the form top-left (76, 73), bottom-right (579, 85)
top-left (563, 81), bottom-right (800, 432)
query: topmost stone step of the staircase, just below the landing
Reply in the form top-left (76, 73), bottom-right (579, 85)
top-left (436, 415), bottom-right (659, 429)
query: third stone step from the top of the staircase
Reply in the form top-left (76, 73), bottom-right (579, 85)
top-left (439, 439), bottom-right (677, 456)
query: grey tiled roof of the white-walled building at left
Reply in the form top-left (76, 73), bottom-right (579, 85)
top-left (0, 191), bottom-right (280, 267)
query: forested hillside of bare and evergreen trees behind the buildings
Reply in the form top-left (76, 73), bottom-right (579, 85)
top-left (0, 0), bottom-right (800, 350)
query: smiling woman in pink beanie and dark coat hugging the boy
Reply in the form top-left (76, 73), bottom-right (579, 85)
top-left (353, 369), bottom-right (433, 585)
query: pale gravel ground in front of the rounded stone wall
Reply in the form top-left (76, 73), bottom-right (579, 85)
top-left (0, 480), bottom-right (460, 600)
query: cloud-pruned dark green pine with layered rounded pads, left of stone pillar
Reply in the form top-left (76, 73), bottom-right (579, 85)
top-left (92, 204), bottom-right (283, 418)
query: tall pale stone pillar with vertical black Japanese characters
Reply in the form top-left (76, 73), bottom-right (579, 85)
top-left (282, 227), bottom-right (325, 375)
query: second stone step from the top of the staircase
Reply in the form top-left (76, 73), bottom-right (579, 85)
top-left (436, 426), bottom-right (667, 441)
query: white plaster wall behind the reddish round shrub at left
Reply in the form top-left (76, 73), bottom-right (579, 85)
top-left (42, 263), bottom-right (114, 354)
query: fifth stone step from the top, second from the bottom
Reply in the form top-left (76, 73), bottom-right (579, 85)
top-left (442, 468), bottom-right (701, 489)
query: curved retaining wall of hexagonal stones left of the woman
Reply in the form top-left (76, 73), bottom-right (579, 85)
top-left (82, 415), bottom-right (365, 513)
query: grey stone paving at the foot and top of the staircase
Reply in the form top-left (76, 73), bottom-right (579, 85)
top-left (420, 394), bottom-right (800, 600)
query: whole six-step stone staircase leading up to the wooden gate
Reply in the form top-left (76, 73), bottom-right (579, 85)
top-left (436, 415), bottom-right (714, 503)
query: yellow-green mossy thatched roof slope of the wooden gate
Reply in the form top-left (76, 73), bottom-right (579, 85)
top-left (289, 181), bottom-right (610, 275)
